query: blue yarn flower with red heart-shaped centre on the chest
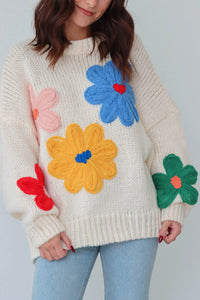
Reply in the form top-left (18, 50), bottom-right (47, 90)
top-left (84, 60), bottom-right (139, 126)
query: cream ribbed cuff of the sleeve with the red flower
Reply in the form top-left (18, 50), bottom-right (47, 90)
top-left (27, 215), bottom-right (65, 247)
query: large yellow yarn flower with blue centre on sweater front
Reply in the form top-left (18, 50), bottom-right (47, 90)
top-left (46, 123), bottom-right (117, 194)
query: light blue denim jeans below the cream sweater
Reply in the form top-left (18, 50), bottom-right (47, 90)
top-left (32, 237), bottom-right (158, 300)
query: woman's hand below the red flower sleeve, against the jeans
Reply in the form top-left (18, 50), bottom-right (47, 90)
top-left (39, 231), bottom-right (72, 261)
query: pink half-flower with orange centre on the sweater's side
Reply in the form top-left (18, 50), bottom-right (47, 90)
top-left (28, 83), bottom-right (61, 142)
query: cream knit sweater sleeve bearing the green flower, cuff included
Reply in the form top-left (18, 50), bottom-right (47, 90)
top-left (131, 33), bottom-right (198, 227)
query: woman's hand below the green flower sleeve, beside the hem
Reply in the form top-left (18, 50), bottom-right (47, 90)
top-left (159, 220), bottom-right (181, 244)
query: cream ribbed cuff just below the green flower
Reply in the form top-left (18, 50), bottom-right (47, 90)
top-left (161, 203), bottom-right (191, 228)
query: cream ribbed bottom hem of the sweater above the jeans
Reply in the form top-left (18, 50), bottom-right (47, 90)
top-left (28, 209), bottom-right (161, 263)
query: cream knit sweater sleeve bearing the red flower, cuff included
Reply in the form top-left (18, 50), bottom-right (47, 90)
top-left (0, 42), bottom-right (65, 247)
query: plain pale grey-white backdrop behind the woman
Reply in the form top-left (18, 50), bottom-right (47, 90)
top-left (0, 0), bottom-right (200, 300)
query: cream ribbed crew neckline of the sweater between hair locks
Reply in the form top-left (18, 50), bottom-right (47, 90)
top-left (63, 36), bottom-right (99, 55)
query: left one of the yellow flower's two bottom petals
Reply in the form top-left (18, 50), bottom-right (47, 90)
top-left (64, 163), bottom-right (85, 193)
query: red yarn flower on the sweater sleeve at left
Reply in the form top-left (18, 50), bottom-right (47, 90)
top-left (17, 163), bottom-right (54, 210)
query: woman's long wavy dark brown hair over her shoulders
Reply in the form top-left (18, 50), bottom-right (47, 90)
top-left (29, 0), bottom-right (134, 81)
